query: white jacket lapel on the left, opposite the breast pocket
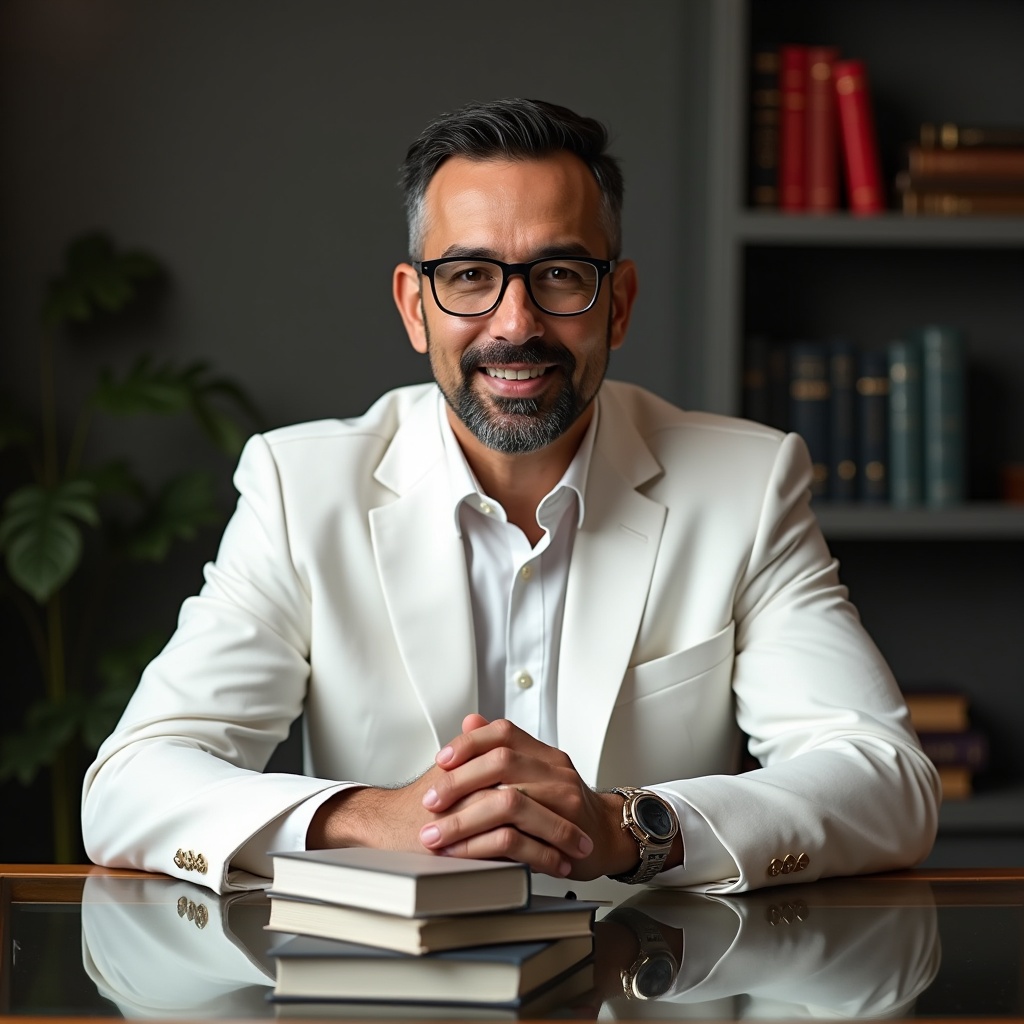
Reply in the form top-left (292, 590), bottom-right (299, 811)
top-left (370, 391), bottom-right (477, 748)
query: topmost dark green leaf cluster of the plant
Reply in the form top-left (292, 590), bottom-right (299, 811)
top-left (43, 231), bottom-right (163, 327)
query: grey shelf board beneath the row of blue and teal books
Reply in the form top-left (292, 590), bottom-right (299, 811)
top-left (814, 502), bottom-right (1024, 541)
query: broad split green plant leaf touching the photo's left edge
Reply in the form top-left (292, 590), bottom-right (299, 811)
top-left (0, 479), bottom-right (99, 604)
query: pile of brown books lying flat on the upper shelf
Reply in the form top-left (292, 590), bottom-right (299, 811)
top-left (896, 123), bottom-right (1024, 217)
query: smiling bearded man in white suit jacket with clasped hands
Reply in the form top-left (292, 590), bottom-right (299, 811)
top-left (83, 99), bottom-right (938, 891)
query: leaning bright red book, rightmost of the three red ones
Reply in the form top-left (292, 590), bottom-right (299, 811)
top-left (833, 60), bottom-right (885, 214)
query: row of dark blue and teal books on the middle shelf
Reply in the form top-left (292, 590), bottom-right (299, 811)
top-left (743, 325), bottom-right (967, 508)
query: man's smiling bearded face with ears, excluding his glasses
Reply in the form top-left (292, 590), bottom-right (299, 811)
top-left (395, 153), bottom-right (633, 455)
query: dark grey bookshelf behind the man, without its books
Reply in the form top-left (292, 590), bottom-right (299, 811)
top-left (691, 0), bottom-right (1024, 866)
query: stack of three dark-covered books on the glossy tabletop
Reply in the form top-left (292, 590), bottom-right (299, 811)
top-left (267, 848), bottom-right (596, 1016)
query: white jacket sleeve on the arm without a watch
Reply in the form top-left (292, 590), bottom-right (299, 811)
top-left (82, 436), bottom-right (338, 893)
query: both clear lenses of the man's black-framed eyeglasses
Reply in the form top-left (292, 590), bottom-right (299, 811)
top-left (434, 259), bottom-right (599, 313)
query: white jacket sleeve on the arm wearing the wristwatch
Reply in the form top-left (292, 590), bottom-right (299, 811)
top-left (658, 435), bottom-right (940, 892)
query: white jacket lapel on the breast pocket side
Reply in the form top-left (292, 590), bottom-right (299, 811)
top-left (558, 388), bottom-right (666, 784)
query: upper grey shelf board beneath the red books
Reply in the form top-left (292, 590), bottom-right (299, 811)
top-left (735, 210), bottom-right (1024, 249)
